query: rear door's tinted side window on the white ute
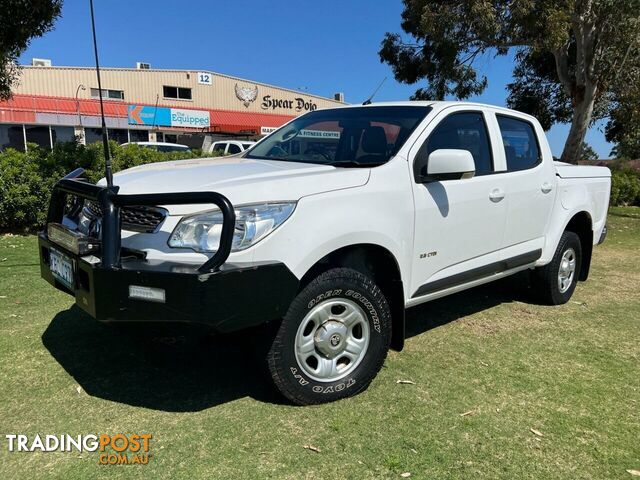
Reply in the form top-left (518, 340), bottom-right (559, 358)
top-left (496, 115), bottom-right (540, 172)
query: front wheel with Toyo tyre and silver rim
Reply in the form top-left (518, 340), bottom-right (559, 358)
top-left (267, 268), bottom-right (391, 405)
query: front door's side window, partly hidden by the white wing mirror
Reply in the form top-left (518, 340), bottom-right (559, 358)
top-left (427, 112), bottom-right (493, 175)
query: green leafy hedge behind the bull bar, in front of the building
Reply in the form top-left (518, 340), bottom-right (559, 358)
top-left (0, 142), bottom-right (215, 232)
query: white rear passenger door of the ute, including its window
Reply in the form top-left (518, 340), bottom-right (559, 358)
top-left (495, 113), bottom-right (556, 257)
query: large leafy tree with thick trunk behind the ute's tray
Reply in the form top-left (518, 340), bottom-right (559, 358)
top-left (379, 0), bottom-right (640, 163)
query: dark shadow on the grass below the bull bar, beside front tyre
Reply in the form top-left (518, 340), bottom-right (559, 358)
top-left (42, 306), bottom-right (284, 412)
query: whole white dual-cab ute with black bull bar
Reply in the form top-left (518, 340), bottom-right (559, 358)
top-left (40, 102), bottom-right (610, 404)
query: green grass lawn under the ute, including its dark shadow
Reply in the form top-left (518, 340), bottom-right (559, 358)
top-left (0, 208), bottom-right (640, 479)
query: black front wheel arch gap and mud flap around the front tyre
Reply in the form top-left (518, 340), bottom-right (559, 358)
top-left (300, 243), bottom-right (405, 351)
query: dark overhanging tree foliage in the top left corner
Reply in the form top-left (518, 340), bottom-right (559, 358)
top-left (0, 0), bottom-right (62, 100)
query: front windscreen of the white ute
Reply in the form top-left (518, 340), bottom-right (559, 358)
top-left (246, 105), bottom-right (431, 167)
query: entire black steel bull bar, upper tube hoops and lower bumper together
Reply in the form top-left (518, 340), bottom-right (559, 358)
top-left (39, 169), bottom-right (298, 332)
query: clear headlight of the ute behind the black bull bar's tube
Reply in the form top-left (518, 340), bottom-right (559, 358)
top-left (169, 202), bottom-right (296, 253)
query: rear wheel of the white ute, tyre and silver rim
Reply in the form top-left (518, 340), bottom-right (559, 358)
top-left (533, 232), bottom-right (582, 305)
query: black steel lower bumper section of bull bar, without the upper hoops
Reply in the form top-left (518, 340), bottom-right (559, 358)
top-left (38, 233), bottom-right (298, 332)
